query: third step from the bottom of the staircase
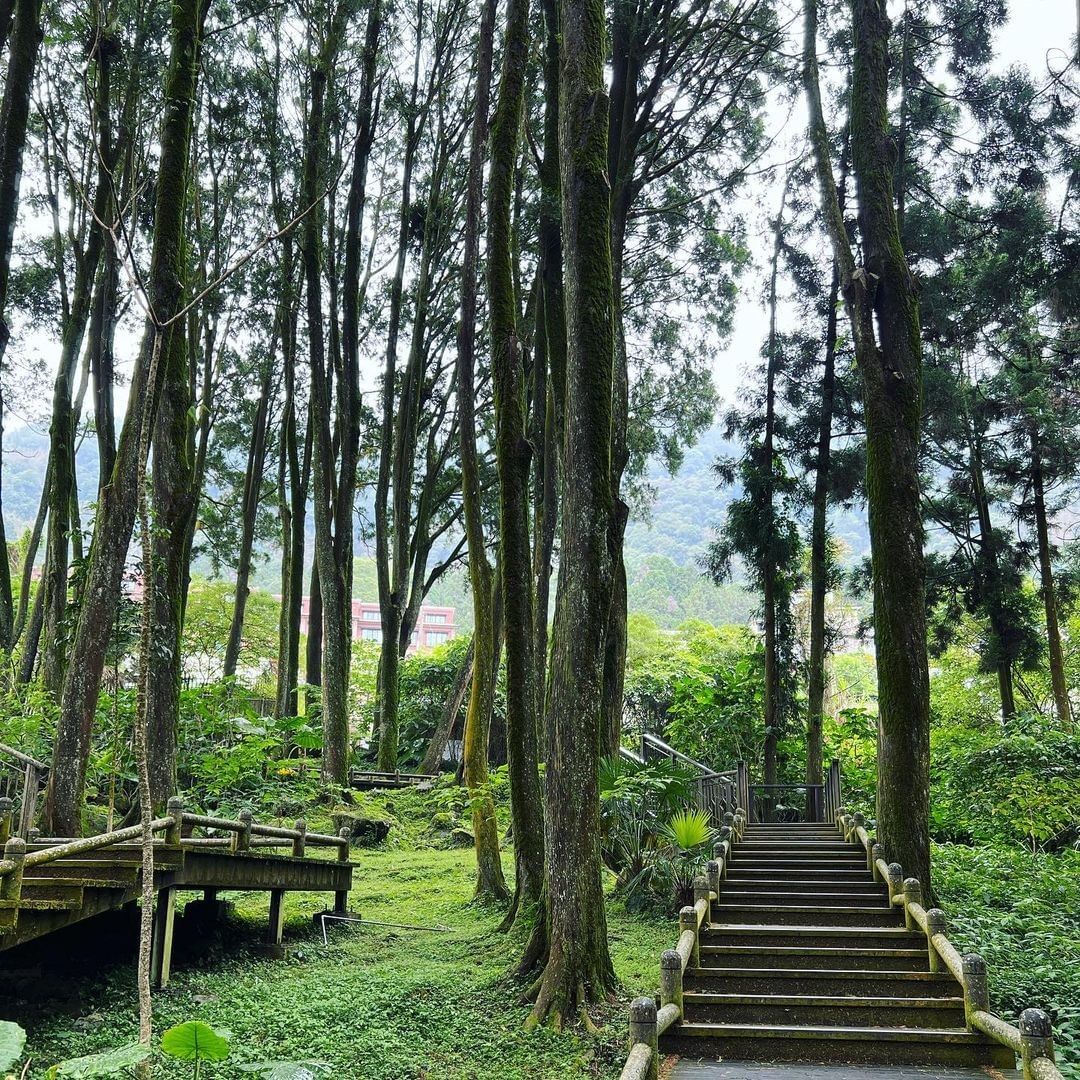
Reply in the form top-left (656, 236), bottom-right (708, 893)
top-left (684, 957), bottom-right (960, 998)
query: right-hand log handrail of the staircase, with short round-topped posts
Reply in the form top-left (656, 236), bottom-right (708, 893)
top-left (836, 807), bottom-right (1063, 1080)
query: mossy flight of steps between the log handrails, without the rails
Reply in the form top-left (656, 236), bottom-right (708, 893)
top-left (661, 824), bottom-right (1015, 1069)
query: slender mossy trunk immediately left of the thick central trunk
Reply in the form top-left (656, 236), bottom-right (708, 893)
top-left (490, 0), bottom-right (545, 924)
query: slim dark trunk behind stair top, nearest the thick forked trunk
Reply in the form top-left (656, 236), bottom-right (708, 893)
top-left (806, 259), bottom-right (840, 784)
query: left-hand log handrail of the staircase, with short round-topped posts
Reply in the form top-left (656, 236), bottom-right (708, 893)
top-left (620, 807), bottom-right (747, 1080)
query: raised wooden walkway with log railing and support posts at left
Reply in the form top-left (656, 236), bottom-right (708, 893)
top-left (0, 798), bottom-right (353, 986)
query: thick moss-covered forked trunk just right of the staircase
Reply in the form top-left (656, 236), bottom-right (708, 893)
top-left (804, 0), bottom-right (930, 893)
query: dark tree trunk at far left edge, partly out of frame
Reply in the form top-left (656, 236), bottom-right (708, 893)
top-left (0, 0), bottom-right (41, 652)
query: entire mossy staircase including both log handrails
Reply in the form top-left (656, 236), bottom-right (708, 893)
top-left (622, 762), bottom-right (1062, 1080)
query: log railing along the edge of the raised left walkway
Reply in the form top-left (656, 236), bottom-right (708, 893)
top-left (0, 796), bottom-right (350, 920)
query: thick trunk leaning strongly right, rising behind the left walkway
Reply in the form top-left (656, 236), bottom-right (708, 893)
top-left (44, 0), bottom-right (206, 836)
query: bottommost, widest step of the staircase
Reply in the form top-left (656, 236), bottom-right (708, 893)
top-left (660, 1024), bottom-right (1016, 1068)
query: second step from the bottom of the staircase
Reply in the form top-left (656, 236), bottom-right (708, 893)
top-left (684, 990), bottom-right (963, 1028)
